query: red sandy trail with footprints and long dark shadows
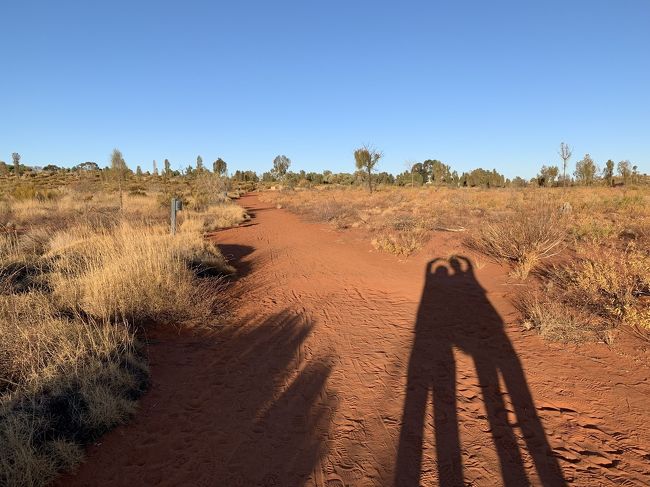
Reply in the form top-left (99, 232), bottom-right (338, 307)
top-left (60, 196), bottom-right (650, 487)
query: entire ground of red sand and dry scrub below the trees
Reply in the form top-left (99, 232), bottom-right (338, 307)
top-left (0, 165), bottom-right (650, 487)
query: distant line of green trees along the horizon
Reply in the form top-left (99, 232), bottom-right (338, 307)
top-left (0, 142), bottom-right (642, 192)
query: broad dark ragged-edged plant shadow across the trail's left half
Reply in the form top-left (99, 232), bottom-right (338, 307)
top-left (57, 311), bottom-right (336, 487)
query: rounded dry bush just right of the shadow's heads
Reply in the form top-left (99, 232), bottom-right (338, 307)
top-left (466, 204), bottom-right (566, 279)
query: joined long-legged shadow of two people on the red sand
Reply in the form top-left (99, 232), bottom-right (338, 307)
top-left (395, 257), bottom-right (566, 487)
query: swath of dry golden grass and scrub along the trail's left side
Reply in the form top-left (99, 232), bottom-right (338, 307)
top-left (0, 181), bottom-right (245, 486)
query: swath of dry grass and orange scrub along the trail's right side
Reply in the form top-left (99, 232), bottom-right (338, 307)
top-left (263, 184), bottom-right (650, 342)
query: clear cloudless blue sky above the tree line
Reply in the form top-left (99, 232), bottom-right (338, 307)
top-left (0, 0), bottom-right (650, 177)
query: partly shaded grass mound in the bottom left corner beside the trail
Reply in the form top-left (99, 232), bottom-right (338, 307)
top-left (0, 293), bottom-right (147, 486)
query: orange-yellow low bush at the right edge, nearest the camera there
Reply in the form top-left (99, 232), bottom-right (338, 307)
top-left (518, 244), bottom-right (650, 342)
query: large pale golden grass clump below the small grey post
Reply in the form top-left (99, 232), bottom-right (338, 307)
top-left (48, 223), bottom-right (218, 323)
